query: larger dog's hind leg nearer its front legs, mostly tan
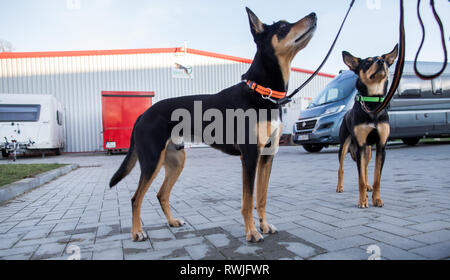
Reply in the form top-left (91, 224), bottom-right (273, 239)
top-left (157, 142), bottom-right (186, 227)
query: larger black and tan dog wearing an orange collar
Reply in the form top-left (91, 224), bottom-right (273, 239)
top-left (110, 8), bottom-right (317, 242)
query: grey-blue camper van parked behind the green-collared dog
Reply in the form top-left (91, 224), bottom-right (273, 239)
top-left (292, 62), bottom-right (450, 152)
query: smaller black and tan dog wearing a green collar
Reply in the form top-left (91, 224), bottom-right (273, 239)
top-left (336, 45), bottom-right (398, 208)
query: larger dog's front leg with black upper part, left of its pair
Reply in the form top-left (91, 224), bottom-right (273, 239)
top-left (241, 148), bottom-right (264, 242)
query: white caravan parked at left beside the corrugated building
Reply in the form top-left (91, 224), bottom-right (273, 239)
top-left (0, 94), bottom-right (65, 159)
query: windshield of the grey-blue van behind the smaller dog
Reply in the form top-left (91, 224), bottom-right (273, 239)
top-left (308, 72), bottom-right (357, 108)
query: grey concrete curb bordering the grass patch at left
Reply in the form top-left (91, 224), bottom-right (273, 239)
top-left (0, 164), bottom-right (78, 203)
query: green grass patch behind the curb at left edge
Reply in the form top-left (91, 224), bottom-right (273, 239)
top-left (0, 163), bottom-right (66, 187)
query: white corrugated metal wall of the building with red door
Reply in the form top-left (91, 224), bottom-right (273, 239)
top-left (0, 49), bottom-right (330, 152)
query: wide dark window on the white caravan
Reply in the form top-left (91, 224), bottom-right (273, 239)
top-left (0, 104), bottom-right (41, 122)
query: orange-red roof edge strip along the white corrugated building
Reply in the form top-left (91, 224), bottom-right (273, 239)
top-left (0, 47), bottom-right (335, 78)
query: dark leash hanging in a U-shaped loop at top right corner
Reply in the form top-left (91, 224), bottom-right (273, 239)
top-left (414, 0), bottom-right (447, 80)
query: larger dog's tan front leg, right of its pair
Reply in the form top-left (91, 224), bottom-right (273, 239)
top-left (256, 155), bottom-right (277, 233)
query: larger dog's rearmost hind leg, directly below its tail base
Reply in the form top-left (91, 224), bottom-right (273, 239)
top-left (131, 143), bottom-right (166, 241)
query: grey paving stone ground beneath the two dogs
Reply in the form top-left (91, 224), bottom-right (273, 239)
top-left (0, 144), bottom-right (450, 260)
